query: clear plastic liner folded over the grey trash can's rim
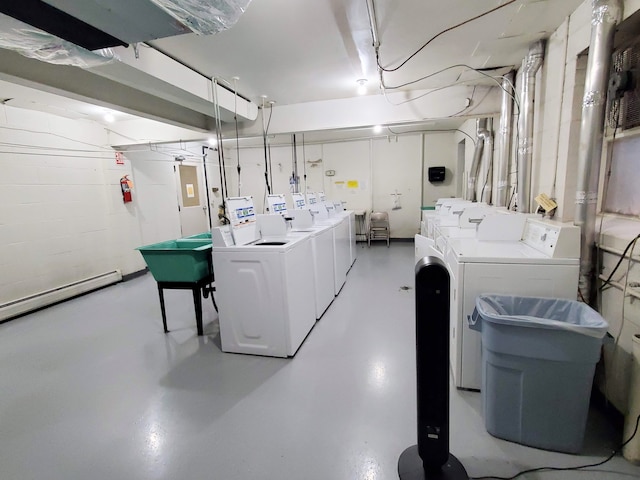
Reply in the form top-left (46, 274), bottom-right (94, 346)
top-left (476, 294), bottom-right (609, 338)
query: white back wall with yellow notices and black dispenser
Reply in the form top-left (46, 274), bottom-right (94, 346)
top-left (224, 133), bottom-right (457, 238)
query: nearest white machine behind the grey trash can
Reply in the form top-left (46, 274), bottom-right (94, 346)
top-left (442, 217), bottom-right (580, 390)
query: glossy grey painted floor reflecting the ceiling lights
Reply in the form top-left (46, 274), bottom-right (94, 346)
top-left (0, 243), bottom-right (640, 480)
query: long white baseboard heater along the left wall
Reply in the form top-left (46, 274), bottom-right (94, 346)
top-left (0, 270), bottom-right (122, 322)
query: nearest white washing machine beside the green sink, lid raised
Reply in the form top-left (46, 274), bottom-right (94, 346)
top-left (213, 197), bottom-right (316, 357)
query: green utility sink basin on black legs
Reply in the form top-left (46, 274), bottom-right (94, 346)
top-left (136, 239), bottom-right (212, 282)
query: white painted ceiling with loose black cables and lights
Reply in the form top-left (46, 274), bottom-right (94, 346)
top-left (0, 0), bottom-right (583, 141)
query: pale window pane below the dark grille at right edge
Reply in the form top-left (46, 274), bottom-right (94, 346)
top-left (604, 131), bottom-right (640, 216)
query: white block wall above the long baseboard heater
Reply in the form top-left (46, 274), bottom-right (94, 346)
top-left (0, 106), bottom-right (144, 303)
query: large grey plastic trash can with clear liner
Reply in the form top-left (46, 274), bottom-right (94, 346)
top-left (469, 294), bottom-right (608, 453)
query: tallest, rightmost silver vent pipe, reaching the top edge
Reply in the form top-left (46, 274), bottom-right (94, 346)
top-left (574, 0), bottom-right (622, 304)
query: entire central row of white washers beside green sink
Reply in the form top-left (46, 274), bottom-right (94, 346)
top-left (212, 196), bottom-right (355, 357)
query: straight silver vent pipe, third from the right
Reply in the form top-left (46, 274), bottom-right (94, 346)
top-left (494, 71), bottom-right (515, 207)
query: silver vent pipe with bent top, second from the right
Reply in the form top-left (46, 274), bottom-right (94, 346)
top-left (518, 40), bottom-right (544, 213)
